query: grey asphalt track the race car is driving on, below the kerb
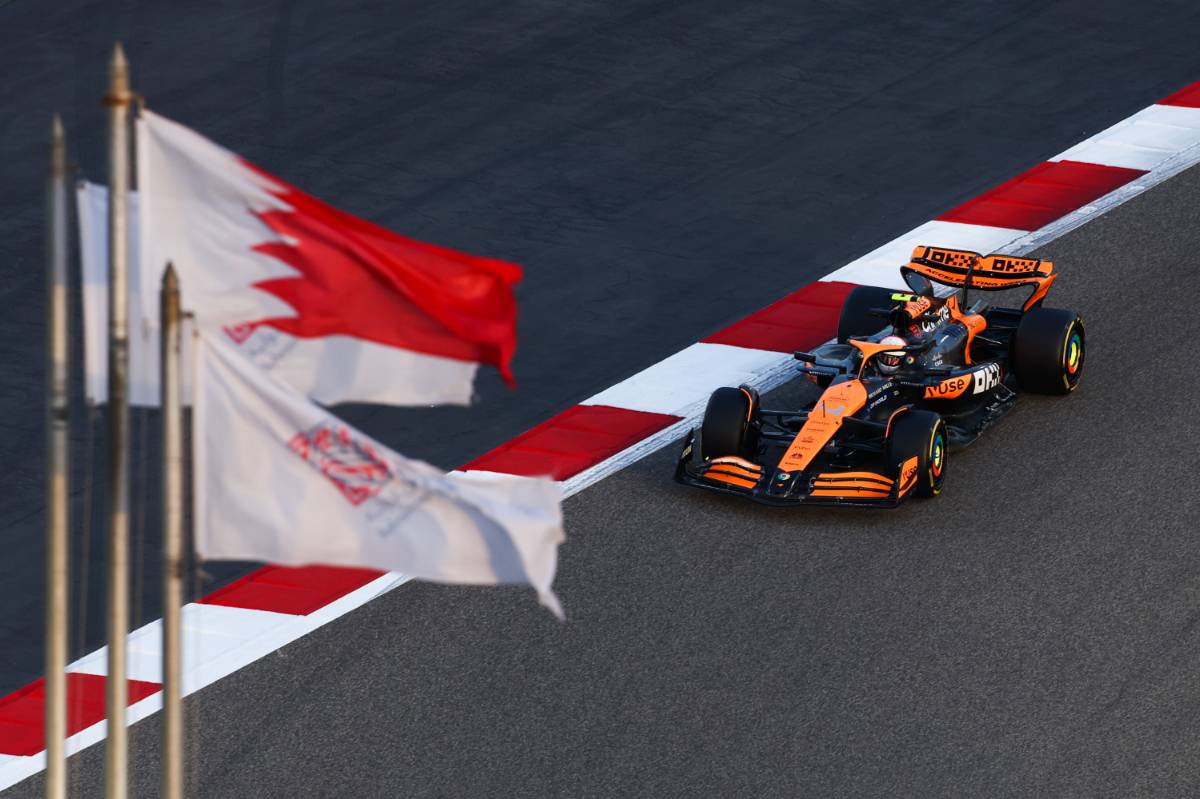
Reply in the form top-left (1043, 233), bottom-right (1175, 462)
top-left (13, 149), bottom-right (1200, 798)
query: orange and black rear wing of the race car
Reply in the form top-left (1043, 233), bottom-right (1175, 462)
top-left (900, 246), bottom-right (1057, 311)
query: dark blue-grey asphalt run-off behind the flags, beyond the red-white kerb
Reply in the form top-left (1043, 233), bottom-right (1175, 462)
top-left (7, 0), bottom-right (1200, 695)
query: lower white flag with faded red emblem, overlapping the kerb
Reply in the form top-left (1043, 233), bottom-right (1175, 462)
top-left (193, 335), bottom-right (564, 618)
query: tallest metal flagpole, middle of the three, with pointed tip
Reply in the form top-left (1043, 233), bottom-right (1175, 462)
top-left (104, 43), bottom-right (132, 799)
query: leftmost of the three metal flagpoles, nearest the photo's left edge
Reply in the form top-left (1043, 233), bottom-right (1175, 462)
top-left (46, 114), bottom-right (70, 799)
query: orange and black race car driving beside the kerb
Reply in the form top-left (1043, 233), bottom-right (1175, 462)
top-left (676, 246), bottom-right (1086, 507)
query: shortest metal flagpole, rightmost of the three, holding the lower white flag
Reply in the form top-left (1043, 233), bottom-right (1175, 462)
top-left (160, 264), bottom-right (184, 799)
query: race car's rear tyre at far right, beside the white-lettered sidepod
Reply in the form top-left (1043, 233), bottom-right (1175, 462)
top-left (1013, 308), bottom-right (1087, 395)
